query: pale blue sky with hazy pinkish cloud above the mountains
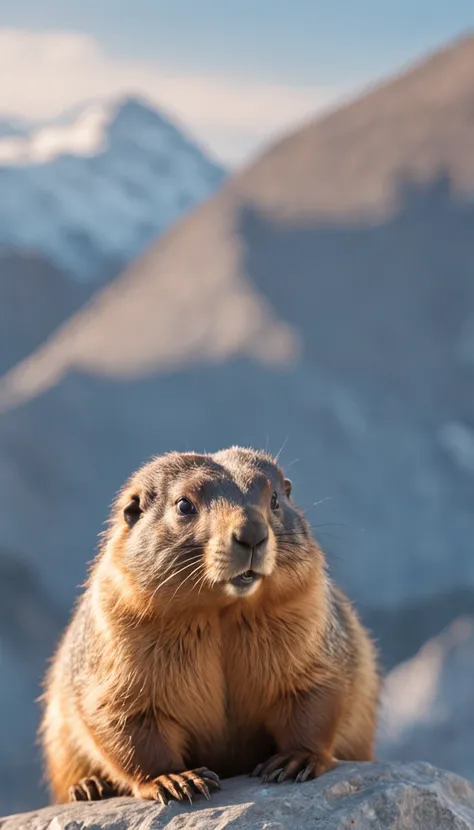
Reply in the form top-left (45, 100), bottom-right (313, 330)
top-left (0, 0), bottom-right (474, 163)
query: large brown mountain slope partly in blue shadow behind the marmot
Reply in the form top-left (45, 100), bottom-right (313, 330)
top-left (0, 38), bottom-right (474, 812)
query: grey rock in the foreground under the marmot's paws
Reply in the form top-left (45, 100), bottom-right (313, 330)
top-left (0, 763), bottom-right (474, 830)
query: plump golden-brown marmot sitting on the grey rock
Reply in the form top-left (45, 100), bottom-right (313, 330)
top-left (40, 447), bottom-right (379, 804)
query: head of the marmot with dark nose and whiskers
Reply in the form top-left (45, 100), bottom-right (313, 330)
top-left (106, 447), bottom-right (322, 604)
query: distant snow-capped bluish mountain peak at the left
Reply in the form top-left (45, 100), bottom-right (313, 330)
top-left (0, 97), bottom-right (225, 280)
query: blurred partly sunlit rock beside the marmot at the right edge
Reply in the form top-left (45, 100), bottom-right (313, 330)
top-left (378, 616), bottom-right (474, 781)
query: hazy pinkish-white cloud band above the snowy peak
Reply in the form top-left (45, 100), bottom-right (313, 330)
top-left (0, 28), bottom-right (345, 162)
